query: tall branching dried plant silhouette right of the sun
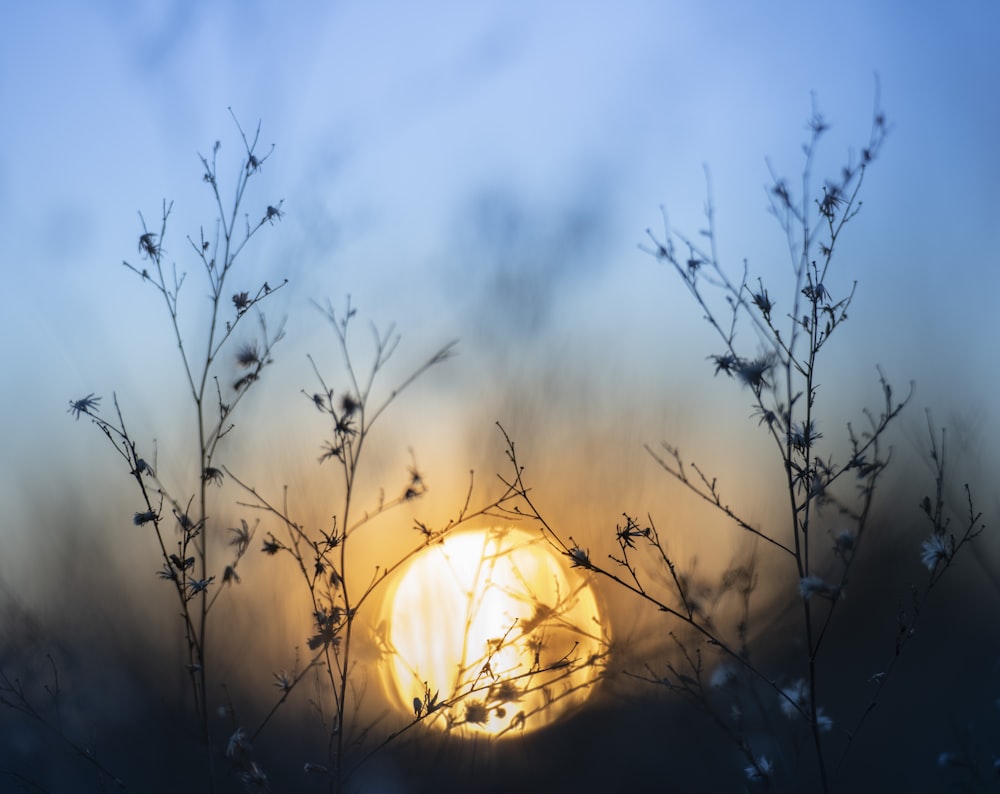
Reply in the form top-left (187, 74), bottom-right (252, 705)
top-left (501, 89), bottom-right (983, 792)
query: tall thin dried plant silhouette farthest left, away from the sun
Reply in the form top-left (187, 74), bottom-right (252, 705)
top-left (63, 111), bottom-right (286, 788)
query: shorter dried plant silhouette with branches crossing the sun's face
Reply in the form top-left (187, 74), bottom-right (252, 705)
top-left (226, 299), bottom-right (600, 792)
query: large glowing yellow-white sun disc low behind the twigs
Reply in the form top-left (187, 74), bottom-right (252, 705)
top-left (376, 529), bottom-right (609, 737)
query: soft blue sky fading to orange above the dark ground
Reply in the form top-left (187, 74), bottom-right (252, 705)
top-left (0, 0), bottom-right (1000, 788)
